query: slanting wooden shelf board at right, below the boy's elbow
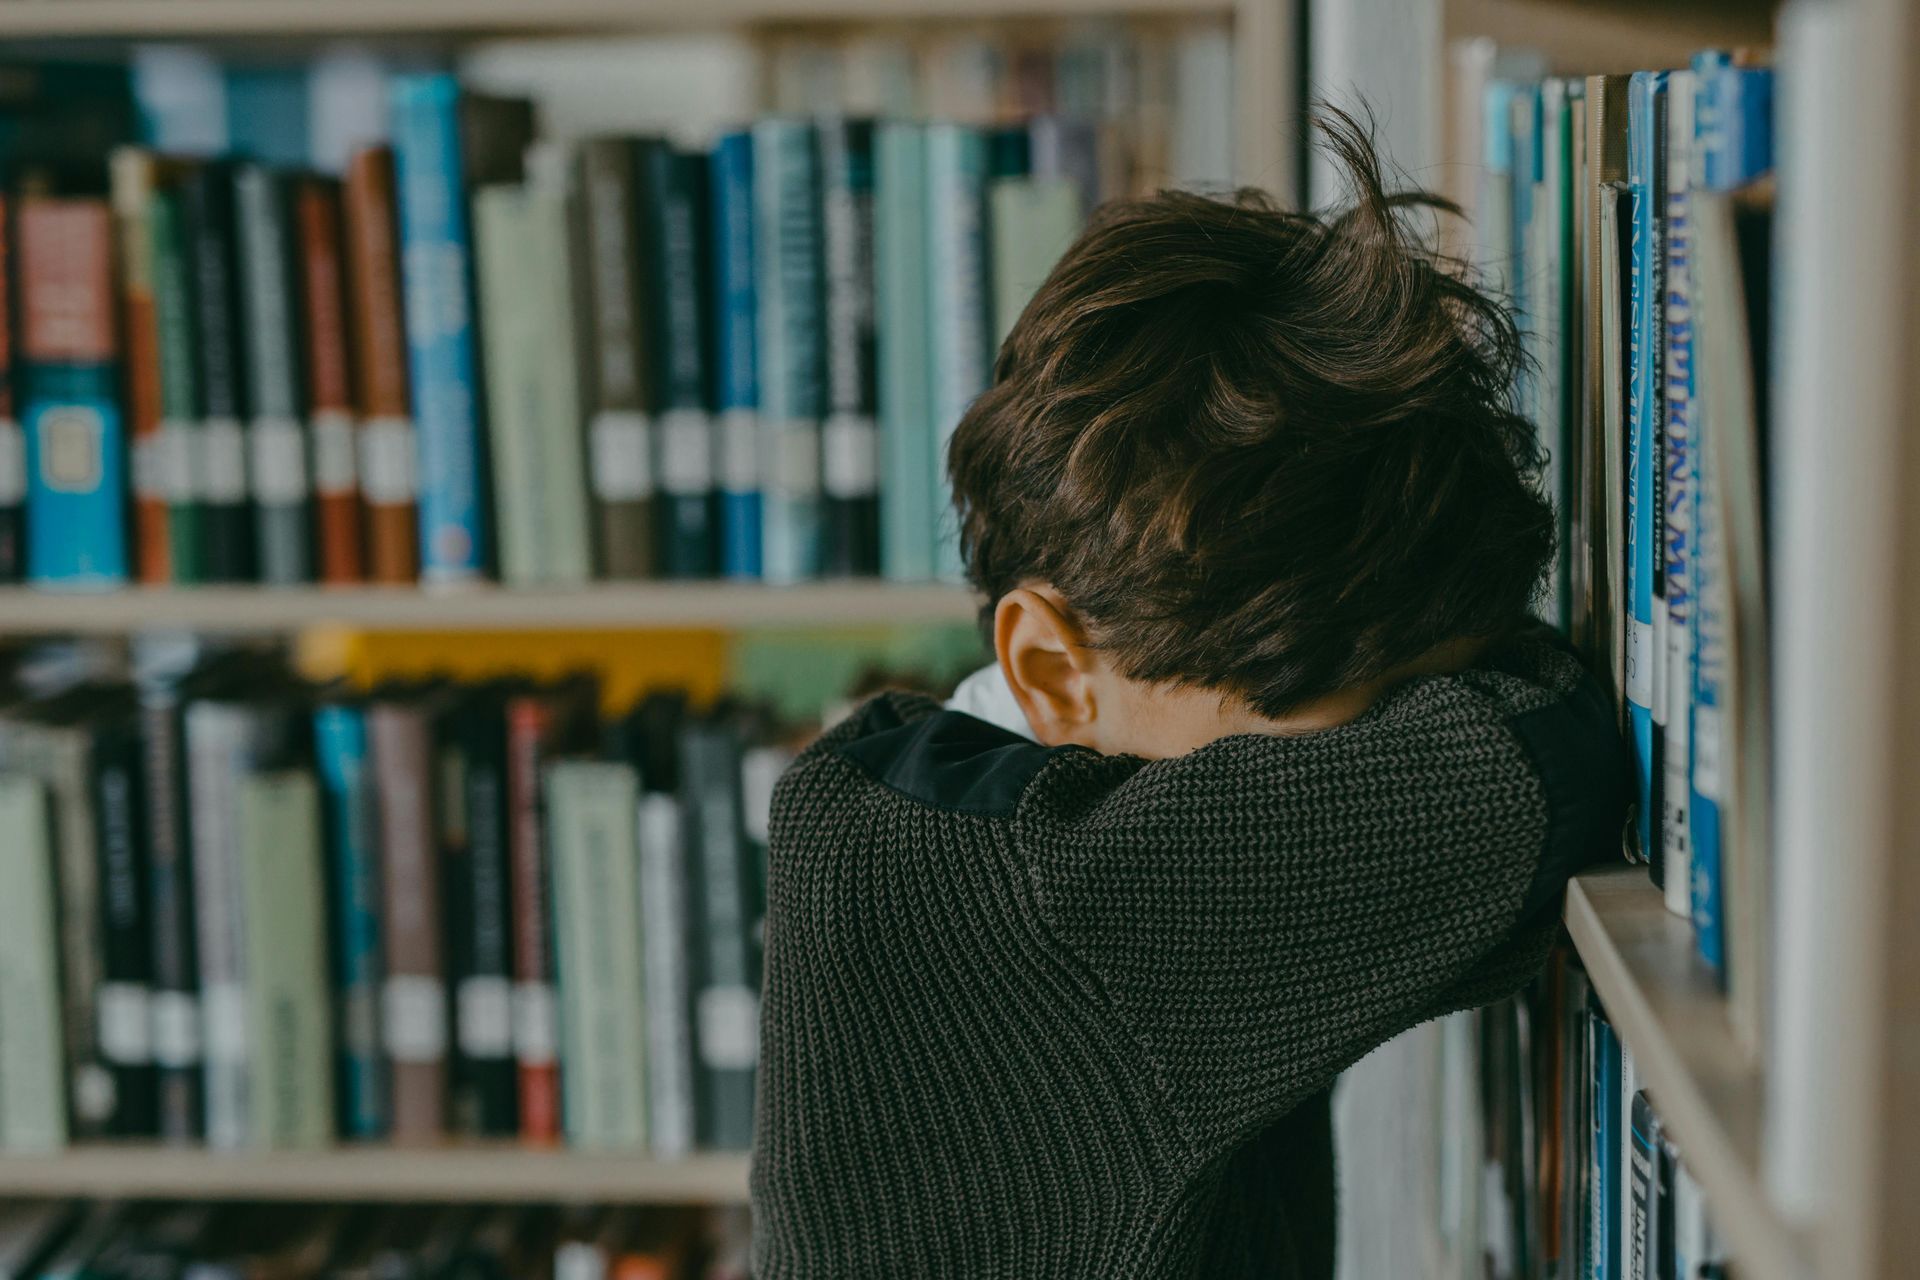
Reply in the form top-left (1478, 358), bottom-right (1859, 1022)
top-left (1567, 865), bottom-right (1811, 1280)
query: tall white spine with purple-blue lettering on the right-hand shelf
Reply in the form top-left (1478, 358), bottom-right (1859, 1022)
top-left (1661, 71), bottom-right (1693, 915)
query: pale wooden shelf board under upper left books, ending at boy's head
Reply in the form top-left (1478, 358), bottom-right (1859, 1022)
top-left (0, 581), bottom-right (977, 635)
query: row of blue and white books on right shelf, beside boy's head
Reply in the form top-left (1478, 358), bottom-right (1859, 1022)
top-left (1476, 52), bottom-right (1774, 1051)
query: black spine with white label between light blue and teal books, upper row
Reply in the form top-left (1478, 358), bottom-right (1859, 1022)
top-left (820, 121), bottom-right (879, 576)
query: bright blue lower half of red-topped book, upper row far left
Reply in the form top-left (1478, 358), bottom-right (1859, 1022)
top-left (21, 365), bottom-right (129, 589)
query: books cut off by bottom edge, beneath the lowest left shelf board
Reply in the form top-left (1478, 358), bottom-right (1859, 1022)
top-left (0, 1201), bottom-right (747, 1280)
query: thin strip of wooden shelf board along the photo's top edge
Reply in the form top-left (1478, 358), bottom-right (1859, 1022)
top-left (0, 0), bottom-right (1233, 36)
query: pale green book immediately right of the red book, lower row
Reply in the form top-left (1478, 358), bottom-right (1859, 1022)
top-left (547, 760), bottom-right (647, 1148)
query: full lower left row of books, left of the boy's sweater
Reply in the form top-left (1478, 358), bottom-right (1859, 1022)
top-left (0, 651), bottom-right (789, 1155)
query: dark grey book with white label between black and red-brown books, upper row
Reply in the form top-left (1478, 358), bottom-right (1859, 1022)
top-left (234, 165), bottom-right (313, 585)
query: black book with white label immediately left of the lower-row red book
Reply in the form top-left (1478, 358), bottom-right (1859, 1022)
top-left (436, 687), bottom-right (518, 1138)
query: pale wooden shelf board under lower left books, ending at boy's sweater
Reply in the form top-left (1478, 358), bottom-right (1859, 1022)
top-left (0, 1144), bottom-right (747, 1205)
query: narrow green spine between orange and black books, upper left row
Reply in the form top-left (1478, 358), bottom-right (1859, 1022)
top-left (148, 186), bottom-right (205, 583)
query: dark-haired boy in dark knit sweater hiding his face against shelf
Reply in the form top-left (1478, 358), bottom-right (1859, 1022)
top-left (753, 123), bottom-right (1626, 1280)
